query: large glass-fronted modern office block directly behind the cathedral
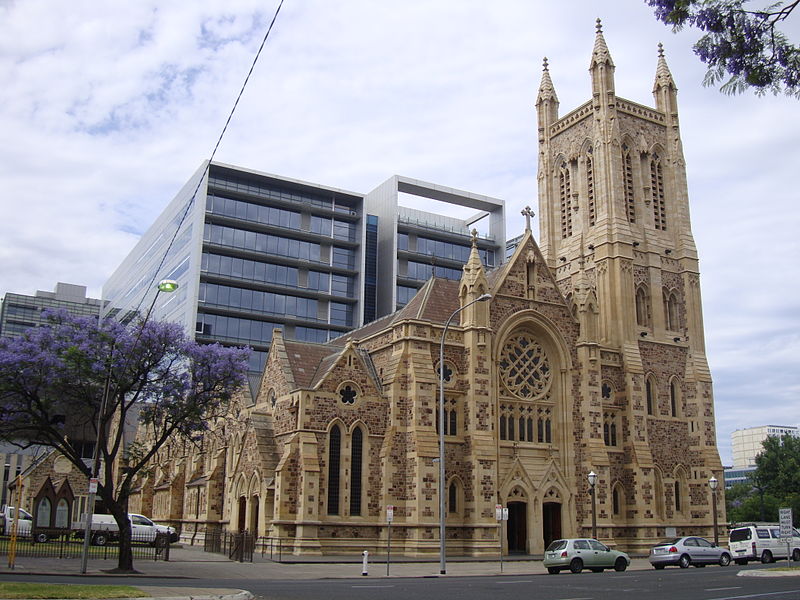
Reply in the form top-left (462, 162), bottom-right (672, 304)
top-left (103, 163), bottom-right (505, 380)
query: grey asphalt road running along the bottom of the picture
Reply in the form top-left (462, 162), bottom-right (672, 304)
top-left (0, 565), bottom-right (800, 600)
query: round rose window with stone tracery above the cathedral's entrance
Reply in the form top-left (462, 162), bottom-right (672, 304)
top-left (500, 333), bottom-right (550, 399)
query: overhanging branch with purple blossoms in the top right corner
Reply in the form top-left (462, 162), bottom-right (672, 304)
top-left (647, 0), bottom-right (800, 98)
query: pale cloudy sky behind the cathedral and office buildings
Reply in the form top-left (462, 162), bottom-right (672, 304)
top-left (0, 0), bottom-right (800, 464)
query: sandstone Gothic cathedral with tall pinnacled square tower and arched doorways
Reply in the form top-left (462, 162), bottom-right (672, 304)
top-left (130, 23), bottom-right (725, 556)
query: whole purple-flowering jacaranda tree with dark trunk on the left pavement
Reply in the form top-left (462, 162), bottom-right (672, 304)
top-left (0, 313), bottom-right (249, 571)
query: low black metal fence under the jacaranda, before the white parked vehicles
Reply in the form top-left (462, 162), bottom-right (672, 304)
top-left (0, 528), bottom-right (169, 561)
